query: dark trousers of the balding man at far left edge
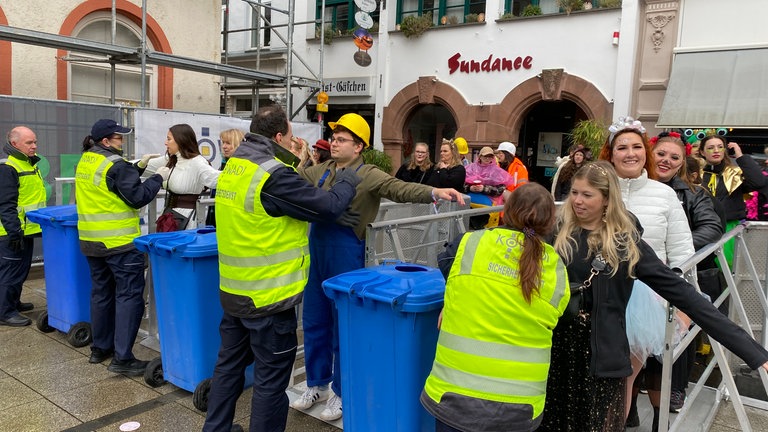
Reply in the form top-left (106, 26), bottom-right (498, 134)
top-left (0, 236), bottom-right (34, 320)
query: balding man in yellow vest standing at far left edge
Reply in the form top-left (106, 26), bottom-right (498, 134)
top-left (0, 126), bottom-right (46, 327)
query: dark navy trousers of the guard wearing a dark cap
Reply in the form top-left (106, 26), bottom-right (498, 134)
top-left (86, 250), bottom-right (144, 360)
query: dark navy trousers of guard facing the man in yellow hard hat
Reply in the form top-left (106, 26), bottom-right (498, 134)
top-left (203, 308), bottom-right (298, 432)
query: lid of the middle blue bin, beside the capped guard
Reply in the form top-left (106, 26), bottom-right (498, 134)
top-left (133, 228), bottom-right (219, 258)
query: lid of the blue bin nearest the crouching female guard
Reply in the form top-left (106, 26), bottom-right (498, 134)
top-left (323, 263), bottom-right (445, 312)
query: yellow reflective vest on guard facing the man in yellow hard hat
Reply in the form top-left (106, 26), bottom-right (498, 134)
top-left (216, 153), bottom-right (309, 318)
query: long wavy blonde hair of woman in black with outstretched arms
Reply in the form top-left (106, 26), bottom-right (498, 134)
top-left (555, 161), bottom-right (640, 277)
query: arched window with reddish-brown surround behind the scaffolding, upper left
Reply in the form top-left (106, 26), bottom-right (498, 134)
top-left (69, 13), bottom-right (157, 106)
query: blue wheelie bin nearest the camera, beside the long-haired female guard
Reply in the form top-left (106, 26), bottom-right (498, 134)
top-left (323, 263), bottom-right (445, 432)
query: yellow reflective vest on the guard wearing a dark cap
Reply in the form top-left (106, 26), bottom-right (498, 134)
top-left (75, 151), bottom-right (141, 249)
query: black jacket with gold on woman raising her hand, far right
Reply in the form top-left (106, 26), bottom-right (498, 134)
top-left (701, 155), bottom-right (766, 221)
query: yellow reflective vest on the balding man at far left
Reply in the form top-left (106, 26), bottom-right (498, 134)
top-left (0, 155), bottom-right (46, 236)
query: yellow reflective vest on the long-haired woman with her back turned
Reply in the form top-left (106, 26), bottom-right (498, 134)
top-left (422, 228), bottom-right (570, 430)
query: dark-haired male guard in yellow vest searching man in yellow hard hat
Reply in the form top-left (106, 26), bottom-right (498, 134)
top-left (203, 106), bottom-right (360, 432)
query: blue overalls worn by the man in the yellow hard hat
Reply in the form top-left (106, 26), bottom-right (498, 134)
top-left (302, 223), bottom-right (365, 396)
